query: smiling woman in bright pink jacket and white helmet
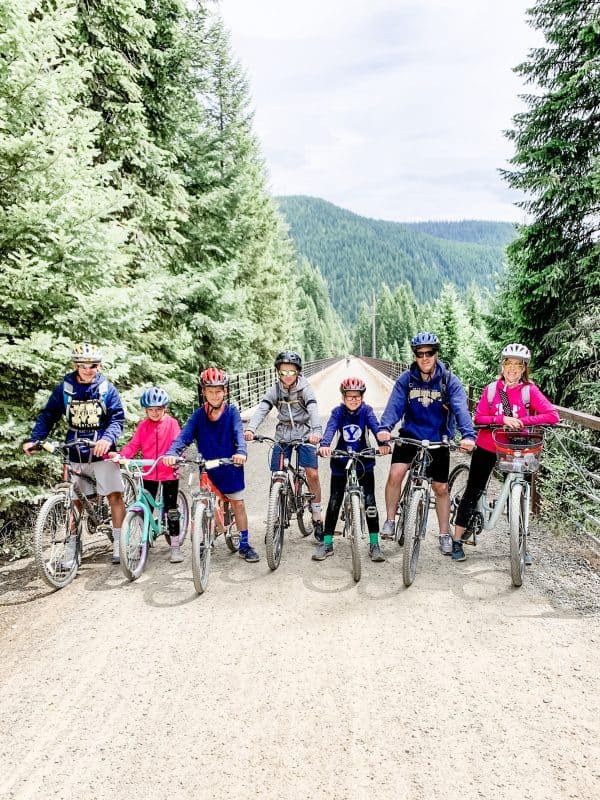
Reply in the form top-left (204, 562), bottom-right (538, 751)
top-left (452, 342), bottom-right (560, 565)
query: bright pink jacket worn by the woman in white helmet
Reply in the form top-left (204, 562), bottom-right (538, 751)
top-left (475, 378), bottom-right (560, 453)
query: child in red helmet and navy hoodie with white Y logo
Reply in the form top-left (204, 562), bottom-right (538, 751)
top-left (312, 378), bottom-right (389, 561)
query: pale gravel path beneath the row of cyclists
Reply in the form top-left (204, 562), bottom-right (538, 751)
top-left (0, 362), bottom-right (600, 800)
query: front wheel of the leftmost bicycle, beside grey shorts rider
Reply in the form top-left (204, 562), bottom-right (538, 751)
top-left (33, 492), bottom-right (81, 589)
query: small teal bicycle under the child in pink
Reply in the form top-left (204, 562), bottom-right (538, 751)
top-left (119, 456), bottom-right (190, 581)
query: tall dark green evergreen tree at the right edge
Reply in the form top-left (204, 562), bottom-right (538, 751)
top-left (492, 0), bottom-right (600, 414)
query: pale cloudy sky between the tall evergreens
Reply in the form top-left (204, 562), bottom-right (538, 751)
top-left (220, 0), bottom-right (540, 222)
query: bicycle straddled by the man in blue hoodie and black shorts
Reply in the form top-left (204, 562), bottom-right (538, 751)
top-left (386, 436), bottom-right (451, 587)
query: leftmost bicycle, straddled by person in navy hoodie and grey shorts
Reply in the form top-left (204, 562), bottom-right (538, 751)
top-left (33, 439), bottom-right (136, 589)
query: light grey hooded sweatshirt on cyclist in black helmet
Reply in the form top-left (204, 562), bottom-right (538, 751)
top-left (246, 375), bottom-right (323, 442)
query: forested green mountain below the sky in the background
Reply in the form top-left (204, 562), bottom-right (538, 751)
top-left (277, 196), bottom-right (516, 322)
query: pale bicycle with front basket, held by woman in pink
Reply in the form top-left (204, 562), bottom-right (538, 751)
top-left (448, 428), bottom-right (544, 588)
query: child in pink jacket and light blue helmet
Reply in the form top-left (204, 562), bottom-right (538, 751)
top-left (119, 386), bottom-right (183, 564)
